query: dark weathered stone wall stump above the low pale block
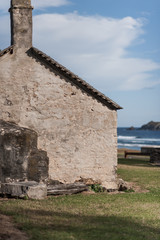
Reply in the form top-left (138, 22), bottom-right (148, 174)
top-left (0, 120), bottom-right (48, 183)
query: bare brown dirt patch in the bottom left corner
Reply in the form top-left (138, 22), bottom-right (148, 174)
top-left (0, 214), bottom-right (28, 240)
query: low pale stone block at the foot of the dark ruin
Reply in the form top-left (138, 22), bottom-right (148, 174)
top-left (1, 181), bottom-right (47, 199)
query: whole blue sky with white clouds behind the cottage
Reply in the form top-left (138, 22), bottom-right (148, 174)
top-left (0, 0), bottom-right (160, 127)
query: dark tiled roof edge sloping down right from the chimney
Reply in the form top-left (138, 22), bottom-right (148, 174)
top-left (30, 47), bottom-right (122, 110)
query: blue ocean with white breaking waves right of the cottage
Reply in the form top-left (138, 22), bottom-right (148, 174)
top-left (118, 128), bottom-right (160, 150)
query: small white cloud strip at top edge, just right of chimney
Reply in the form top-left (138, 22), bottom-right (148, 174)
top-left (32, 0), bottom-right (69, 9)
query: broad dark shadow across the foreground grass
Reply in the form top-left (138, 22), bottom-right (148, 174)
top-left (7, 209), bottom-right (160, 240)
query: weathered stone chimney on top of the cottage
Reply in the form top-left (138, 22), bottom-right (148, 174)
top-left (9, 0), bottom-right (33, 49)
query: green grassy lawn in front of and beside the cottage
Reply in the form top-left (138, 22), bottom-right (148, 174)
top-left (0, 155), bottom-right (160, 240)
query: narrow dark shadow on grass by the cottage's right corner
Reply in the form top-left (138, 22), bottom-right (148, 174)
top-left (118, 158), bottom-right (155, 168)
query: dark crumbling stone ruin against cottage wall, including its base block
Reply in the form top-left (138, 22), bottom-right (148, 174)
top-left (0, 120), bottom-right (49, 199)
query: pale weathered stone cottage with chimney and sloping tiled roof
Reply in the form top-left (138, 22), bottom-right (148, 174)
top-left (0, 0), bottom-right (121, 189)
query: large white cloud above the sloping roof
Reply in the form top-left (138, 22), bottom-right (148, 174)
top-left (34, 12), bottom-right (160, 92)
